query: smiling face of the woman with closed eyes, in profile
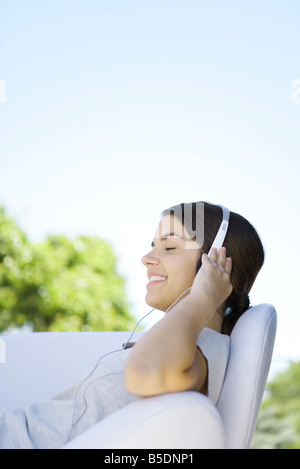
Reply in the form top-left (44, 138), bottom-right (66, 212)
top-left (142, 215), bottom-right (200, 311)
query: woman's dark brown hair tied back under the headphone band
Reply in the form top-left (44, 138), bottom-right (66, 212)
top-left (162, 202), bottom-right (264, 335)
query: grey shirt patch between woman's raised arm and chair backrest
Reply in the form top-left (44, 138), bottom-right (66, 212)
top-left (197, 328), bottom-right (230, 404)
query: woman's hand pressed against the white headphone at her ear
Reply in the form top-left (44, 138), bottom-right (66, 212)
top-left (190, 247), bottom-right (232, 311)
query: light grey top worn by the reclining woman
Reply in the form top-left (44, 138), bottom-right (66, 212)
top-left (0, 328), bottom-right (230, 449)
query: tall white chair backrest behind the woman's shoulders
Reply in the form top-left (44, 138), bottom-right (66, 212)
top-left (217, 303), bottom-right (277, 449)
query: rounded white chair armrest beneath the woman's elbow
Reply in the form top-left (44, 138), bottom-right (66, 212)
top-left (63, 391), bottom-right (225, 449)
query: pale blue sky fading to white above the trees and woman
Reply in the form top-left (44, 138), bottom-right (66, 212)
top-left (0, 0), bottom-right (300, 372)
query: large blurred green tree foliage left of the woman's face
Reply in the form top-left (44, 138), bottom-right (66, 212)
top-left (0, 207), bottom-right (135, 331)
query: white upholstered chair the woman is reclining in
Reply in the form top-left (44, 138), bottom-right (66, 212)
top-left (0, 304), bottom-right (277, 449)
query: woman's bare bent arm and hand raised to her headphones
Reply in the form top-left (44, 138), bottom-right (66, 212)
top-left (125, 248), bottom-right (232, 396)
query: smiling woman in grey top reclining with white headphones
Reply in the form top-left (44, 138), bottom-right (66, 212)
top-left (0, 202), bottom-right (264, 449)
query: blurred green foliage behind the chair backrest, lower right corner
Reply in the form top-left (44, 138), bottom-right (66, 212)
top-left (253, 362), bottom-right (300, 449)
